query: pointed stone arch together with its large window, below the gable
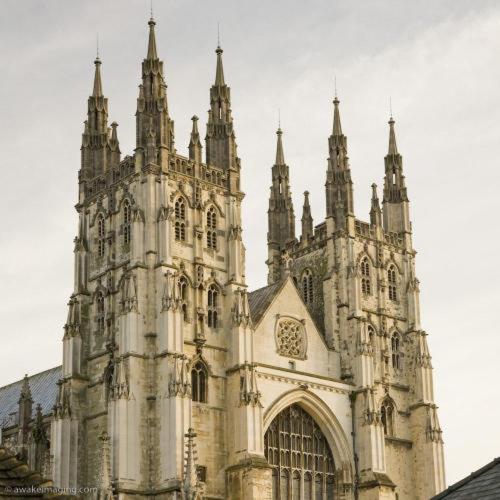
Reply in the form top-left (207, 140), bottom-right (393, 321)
top-left (264, 389), bottom-right (353, 500)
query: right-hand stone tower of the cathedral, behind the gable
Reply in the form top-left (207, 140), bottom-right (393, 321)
top-left (268, 97), bottom-right (445, 498)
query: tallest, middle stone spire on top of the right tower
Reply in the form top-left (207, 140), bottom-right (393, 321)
top-left (325, 96), bottom-right (354, 227)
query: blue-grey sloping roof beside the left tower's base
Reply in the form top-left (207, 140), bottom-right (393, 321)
top-left (0, 366), bottom-right (62, 427)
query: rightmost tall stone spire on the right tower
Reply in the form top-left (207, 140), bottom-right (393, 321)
top-left (383, 116), bottom-right (411, 233)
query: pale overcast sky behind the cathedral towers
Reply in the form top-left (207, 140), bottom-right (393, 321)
top-left (0, 0), bottom-right (500, 483)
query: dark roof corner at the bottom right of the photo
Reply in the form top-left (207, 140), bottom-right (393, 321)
top-left (432, 457), bottom-right (500, 500)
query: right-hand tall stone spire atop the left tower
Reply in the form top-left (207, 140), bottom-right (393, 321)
top-left (205, 46), bottom-right (240, 172)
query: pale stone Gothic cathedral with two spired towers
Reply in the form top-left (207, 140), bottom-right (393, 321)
top-left (0, 15), bottom-right (445, 500)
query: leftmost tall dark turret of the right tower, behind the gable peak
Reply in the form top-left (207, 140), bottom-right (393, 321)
top-left (267, 128), bottom-right (295, 283)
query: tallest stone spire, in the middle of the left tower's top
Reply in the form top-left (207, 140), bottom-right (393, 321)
top-left (135, 18), bottom-right (175, 169)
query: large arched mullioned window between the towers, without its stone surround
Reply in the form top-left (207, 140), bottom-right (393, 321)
top-left (264, 404), bottom-right (335, 500)
